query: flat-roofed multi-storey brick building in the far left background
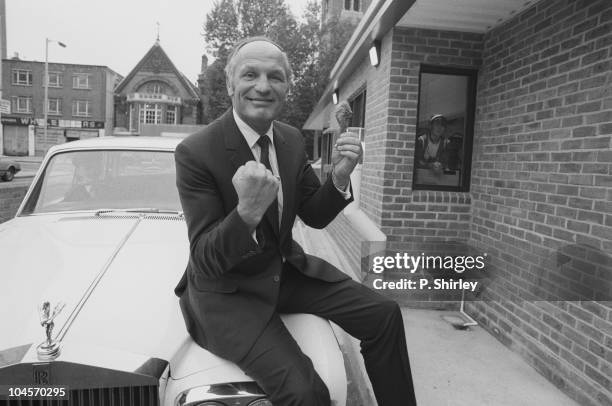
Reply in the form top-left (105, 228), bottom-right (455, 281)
top-left (0, 58), bottom-right (121, 155)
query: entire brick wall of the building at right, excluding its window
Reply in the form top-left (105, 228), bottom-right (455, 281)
top-left (322, 0), bottom-right (612, 405)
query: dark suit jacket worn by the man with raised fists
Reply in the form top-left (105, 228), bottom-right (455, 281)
top-left (175, 109), bottom-right (351, 361)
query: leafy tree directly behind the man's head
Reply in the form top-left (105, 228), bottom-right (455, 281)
top-left (203, 0), bottom-right (354, 128)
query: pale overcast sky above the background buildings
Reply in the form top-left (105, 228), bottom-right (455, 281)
top-left (6, 0), bottom-right (314, 82)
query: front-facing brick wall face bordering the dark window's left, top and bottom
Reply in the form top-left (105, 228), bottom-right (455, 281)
top-left (381, 28), bottom-right (483, 244)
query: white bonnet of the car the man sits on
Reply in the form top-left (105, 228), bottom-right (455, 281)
top-left (0, 213), bottom-right (189, 359)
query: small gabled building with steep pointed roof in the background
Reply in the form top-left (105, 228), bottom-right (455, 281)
top-left (115, 40), bottom-right (202, 135)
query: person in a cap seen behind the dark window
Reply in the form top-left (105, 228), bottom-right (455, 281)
top-left (416, 114), bottom-right (447, 174)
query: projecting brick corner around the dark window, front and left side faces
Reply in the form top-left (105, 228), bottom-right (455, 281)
top-left (328, 28), bottom-right (483, 294)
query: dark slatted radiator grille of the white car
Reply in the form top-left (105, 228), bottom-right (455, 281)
top-left (8, 385), bottom-right (159, 406)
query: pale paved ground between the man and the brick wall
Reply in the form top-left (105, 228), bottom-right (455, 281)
top-left (294, 222), bottom-right (577, 406)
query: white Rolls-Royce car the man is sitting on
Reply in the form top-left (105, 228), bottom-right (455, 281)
top-left (0, 137), bottom-right (346, 406)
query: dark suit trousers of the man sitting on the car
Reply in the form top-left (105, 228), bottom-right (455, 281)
top-left (238, 265), bottom-right (416, 406)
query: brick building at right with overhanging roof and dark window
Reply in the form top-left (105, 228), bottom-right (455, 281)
top-left (304, 0), bottom-right (612, 405)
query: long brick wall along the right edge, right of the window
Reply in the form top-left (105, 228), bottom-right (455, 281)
top-left (467, 0), bottom-right (612, 405)
